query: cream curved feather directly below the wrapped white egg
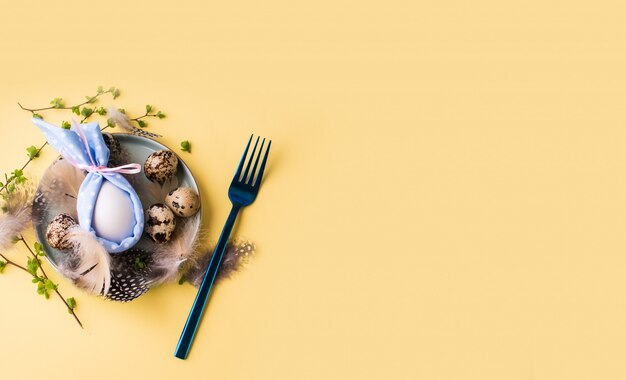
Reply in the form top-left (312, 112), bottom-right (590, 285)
top-left (61, 226), bottom-right (111, 295)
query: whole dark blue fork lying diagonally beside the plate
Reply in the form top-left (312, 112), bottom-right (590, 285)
top-left (174, 136), bottom-right (272, 359)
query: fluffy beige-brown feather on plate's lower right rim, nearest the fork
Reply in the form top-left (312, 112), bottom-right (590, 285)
top-left (149, 213), bottom-right (200, 286)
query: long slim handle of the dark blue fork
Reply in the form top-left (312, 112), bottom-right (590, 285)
top-left (174, 203), bottom-right (241, 359)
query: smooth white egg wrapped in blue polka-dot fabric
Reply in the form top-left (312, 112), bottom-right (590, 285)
top-left (92, 180), bottom-right (135, 243)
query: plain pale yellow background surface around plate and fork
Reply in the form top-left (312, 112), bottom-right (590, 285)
top-left (0, 0), bottom-right (626, 379)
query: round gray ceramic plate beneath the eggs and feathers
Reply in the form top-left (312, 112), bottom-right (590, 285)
top-left (33, 133), bottom-right (200, 284)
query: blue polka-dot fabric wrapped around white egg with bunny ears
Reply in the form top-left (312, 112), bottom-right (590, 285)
top-left (33, 118), bottom-right (144, 253)
